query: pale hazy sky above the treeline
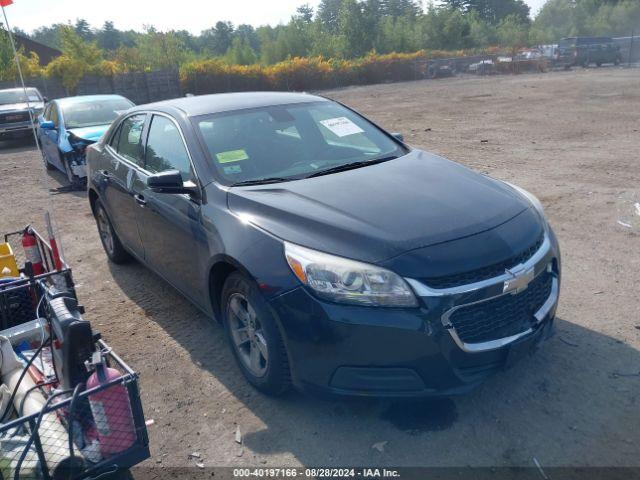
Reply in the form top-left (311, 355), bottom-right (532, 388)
top-left (6, 0), bottom-right (545, 33)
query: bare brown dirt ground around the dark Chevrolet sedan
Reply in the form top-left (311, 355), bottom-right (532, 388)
top-left (0, 68), bottom-right (640, 473)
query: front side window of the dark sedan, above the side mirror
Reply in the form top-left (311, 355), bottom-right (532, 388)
top-left (145, 115), bottom-right (192, 180)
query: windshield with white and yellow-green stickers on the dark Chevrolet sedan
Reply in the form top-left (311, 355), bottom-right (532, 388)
top-left (194, 101), bottom-right (406, 185)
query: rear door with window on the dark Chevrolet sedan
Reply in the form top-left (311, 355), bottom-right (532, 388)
top-left (101, 113), bottom-right (147, 258)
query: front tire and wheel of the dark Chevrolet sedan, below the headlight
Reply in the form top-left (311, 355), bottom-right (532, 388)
top-left (220, 272), bottom-right (291, 395)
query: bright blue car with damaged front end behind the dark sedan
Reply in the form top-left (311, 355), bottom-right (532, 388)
top-left (38, 95), bottom-right (134, 189)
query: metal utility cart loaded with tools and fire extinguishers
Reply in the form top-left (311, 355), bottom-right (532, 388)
top-left (0, 227), bottom-right (149, 480)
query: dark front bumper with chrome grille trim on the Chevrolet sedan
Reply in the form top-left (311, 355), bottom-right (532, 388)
top-left (270, 232), bottom-right (560, 397)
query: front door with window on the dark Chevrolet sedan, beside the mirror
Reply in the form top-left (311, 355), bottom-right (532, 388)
top-left (134, 114), bottom-right (207, 305)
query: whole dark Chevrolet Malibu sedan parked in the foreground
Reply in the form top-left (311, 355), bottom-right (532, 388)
top-left (88, 93), bottom-right (560, 397)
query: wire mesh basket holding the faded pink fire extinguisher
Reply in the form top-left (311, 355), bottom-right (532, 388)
top-left (0, 344), bottom-right (149, 480)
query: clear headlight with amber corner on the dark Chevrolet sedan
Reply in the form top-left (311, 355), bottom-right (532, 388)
top-left (284, 242), bottom-right (418, 307)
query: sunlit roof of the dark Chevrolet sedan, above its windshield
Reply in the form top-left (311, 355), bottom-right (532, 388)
top-left (130, 92), bottom-right (329, 117)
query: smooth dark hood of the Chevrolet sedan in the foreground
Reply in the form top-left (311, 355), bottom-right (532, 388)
top-left (227, 150), bottom-right (529, 263)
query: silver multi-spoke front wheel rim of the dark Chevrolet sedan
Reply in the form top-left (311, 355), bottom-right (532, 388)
top-left (227, 293), bottom-right (269, 377)
